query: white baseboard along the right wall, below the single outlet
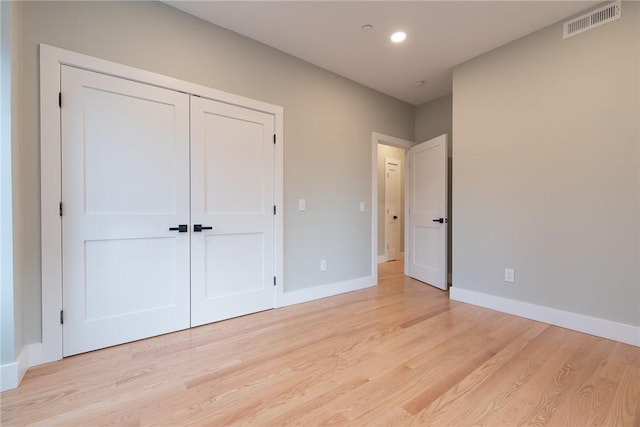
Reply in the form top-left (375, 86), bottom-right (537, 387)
top-left (449, 286), bottom-right (640, 347)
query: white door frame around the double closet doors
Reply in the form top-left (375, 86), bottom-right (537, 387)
top-left (37, 44), bottom-right (284, 366)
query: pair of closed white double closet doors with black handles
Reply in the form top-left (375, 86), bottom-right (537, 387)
top-left (61, 66), bottom-right (275, 356)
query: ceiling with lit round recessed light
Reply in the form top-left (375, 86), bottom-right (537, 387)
top-left (165, 0), bottom-right (600, 105)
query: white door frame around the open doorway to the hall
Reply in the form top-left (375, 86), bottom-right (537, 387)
top-left (371, 132), bottom-right (415, 283)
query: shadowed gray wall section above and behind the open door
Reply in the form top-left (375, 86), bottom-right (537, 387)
top-left (414, 94), bottom-right (453, 274)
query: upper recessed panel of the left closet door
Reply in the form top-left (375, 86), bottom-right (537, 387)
top-left (82, 87), bottom-right (179, 215)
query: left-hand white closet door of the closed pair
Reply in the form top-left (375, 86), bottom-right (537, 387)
top-left (61, 66), bottom-right (189, 356)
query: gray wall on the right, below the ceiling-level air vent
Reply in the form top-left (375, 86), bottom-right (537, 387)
top-left (453, 2), bottom-right (640, 325)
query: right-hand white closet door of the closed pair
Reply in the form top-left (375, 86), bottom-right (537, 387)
top-left (191, 97), bottom-right (275, 326)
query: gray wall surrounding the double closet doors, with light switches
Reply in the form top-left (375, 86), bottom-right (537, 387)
top-left (13, 2), bottom-right (413, 343)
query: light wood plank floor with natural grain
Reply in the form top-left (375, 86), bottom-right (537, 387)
top-left (1, 262), bottom-right (640, 426)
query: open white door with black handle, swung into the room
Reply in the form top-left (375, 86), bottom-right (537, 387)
top-left (406, 135), bottom-right (448, 290)
